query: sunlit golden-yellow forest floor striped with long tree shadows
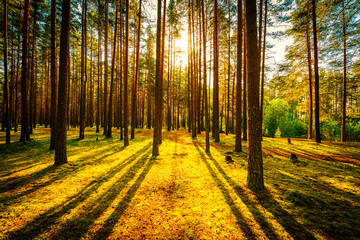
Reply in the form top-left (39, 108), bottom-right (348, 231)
top-left (0, 128), bottom-right (360, 239)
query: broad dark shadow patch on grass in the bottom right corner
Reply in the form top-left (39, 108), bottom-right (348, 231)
top-left (272, 173), bottom-right (360, 239)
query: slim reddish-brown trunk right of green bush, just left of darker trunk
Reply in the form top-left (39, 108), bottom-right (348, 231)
top-left (306, 8), bottom-right (314, 139)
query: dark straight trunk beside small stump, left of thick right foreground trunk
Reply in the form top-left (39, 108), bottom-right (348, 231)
top-left (235, 0), bottom-right (243, 152)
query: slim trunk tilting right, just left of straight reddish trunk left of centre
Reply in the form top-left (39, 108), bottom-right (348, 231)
top-left (106, 8), bottom-right (118, 138)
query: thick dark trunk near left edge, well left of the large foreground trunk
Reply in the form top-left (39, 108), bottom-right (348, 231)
top-left (20, 0), bottom-right (30, 143)
